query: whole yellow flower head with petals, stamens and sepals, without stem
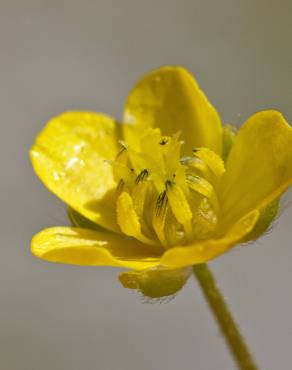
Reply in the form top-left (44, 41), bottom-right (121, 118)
top-left (30, 67), bottom-right (292, 297)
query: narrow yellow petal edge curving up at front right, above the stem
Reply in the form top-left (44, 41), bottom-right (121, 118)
top-left (161, 210), bottom-right (259, 268)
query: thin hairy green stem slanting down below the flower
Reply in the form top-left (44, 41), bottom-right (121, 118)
top-left (193, 264), bottom-right (257, 370)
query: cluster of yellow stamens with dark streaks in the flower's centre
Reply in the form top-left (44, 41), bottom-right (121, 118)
top-left (112, 129), bottom-right (224, 248)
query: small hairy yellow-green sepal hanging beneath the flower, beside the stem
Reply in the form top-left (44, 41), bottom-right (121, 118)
top-left (119, 268), bottom-right (191, 298)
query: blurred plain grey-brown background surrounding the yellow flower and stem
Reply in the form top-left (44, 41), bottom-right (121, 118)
top-left (0, 0), bottom-right (292, 370)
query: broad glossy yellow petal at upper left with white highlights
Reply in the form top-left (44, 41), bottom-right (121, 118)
top-left (30, 112), bottom-right (119, 231)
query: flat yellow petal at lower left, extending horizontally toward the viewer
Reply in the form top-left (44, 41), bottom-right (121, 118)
top-left (31, 227), bottom-right (159, 270)
